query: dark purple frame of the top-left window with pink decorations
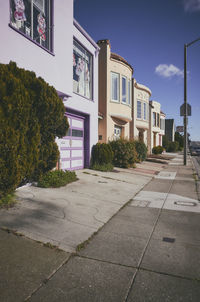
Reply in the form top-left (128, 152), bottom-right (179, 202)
top-left (8, 0), bottom-right (55, 56)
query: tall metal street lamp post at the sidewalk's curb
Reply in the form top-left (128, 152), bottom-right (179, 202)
top-left (183, 38), bottom-right (200, 166)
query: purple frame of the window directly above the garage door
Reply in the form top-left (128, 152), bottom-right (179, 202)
top-left (73, 37), bottom-right (94, 101)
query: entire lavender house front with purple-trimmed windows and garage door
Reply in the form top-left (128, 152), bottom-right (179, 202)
top-left (0, 0), bottom-right (99, 170)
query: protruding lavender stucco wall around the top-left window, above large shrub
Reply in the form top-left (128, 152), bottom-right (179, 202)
top-left (0, 0), bottom-right (73, 95)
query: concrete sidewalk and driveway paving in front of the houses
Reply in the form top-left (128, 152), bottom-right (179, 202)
top-left (0, 155), bottom-right (200, 302)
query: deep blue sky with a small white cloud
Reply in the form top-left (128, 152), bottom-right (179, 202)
top-left (74, 0), bottom-right (200, 141)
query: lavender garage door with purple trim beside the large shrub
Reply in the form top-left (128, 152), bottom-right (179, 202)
top-left (60, 115), bottom-right (84, 170)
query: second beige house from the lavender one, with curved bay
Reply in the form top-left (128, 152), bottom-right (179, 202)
top-left (133, 79), bottom-right (151, 152)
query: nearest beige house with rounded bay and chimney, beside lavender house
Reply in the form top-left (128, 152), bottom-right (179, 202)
top-left (97, 40), bottom-right (133, 142)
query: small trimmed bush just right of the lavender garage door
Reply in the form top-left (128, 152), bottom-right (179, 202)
top-left (90, 143), bottom-right (113, 171)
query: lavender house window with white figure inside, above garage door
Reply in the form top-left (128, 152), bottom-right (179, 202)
top-left (73, 40), bottom-right (93, 99)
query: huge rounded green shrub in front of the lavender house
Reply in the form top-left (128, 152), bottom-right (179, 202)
top-left (0, 62), bottom-right (68, 198)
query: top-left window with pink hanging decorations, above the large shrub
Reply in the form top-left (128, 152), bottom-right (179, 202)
top-left (10, 0), bottom-right (53, 51)
